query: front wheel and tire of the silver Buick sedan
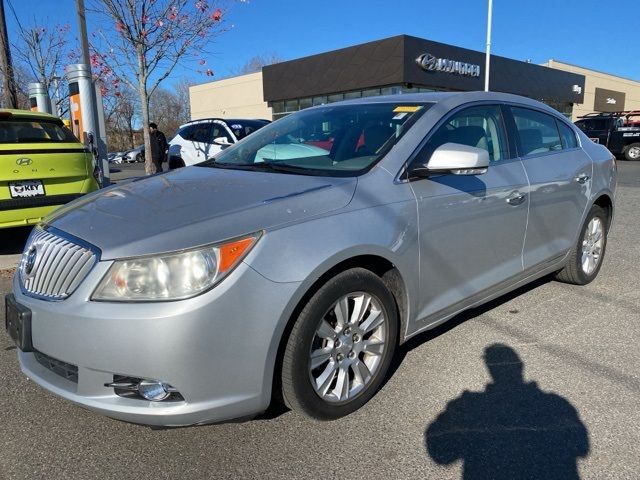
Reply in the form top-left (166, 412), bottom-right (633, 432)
top-left (282, 268), bottom-right (398, 420)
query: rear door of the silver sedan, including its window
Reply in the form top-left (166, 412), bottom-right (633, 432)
top-left (511, 107), bottom-right (593, 268)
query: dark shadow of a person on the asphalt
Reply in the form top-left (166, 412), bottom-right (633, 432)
top-left (425, 344), bottom-right (589, 480)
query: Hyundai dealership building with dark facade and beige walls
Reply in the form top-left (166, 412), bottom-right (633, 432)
top-left (189, 35), bottom-right (640, 120)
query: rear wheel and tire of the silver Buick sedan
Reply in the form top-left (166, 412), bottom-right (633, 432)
top-left (556, 205), bottom-right (608, 285)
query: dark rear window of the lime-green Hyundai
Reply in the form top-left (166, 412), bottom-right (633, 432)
top-left (0, 118), bottom-right (78, 143)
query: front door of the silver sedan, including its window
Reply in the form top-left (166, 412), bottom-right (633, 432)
top-left (411, 105), bottom-right (528, 329)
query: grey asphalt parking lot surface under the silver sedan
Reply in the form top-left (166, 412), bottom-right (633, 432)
top-left (0, 162), bottom-right (640, 480)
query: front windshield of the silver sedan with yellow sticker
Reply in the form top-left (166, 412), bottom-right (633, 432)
top-left (200, 102), bottom-right (431, 176)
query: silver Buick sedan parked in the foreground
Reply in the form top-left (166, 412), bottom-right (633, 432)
top-left (6, 92), bottom-right (616, 425)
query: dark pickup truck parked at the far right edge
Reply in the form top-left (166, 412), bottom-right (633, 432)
top-left (575, 110), bottom-right (640, 161)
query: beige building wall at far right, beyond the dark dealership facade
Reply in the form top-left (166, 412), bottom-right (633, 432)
top-left (543, 60), bottom-right (640, 121)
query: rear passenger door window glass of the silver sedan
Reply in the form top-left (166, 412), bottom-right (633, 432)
top-left (511, 107), bottom-right (562, 157)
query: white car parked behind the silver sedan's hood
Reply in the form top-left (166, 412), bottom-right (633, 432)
top-left (169, 118), bottom-right (270, 170)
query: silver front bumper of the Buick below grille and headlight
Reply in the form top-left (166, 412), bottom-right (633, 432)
top-left (14, 262), bottom-right (299, 426)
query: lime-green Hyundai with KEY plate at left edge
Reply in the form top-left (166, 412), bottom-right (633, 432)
top-left (0, 110), bottom-right (99, 228)
